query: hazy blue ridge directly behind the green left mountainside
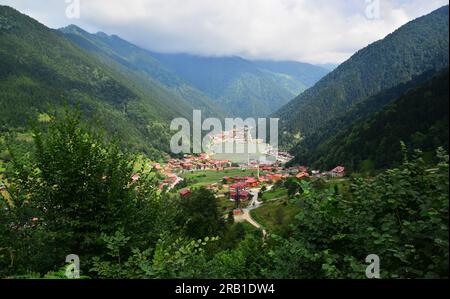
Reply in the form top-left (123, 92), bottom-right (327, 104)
top-left (60, 25), bottom-right (224, 117)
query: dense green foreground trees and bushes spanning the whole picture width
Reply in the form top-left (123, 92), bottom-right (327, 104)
top-left (0, 112), bottom-right (449, 279)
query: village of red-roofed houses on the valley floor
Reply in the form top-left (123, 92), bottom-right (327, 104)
top-left (132, 129), bottom-right (345, 234)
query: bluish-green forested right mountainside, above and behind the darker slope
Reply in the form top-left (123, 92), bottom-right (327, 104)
top-left (273, 6), bottom-right (449, 145)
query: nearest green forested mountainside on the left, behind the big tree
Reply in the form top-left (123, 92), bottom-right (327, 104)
top-left (0, 6), bottom-right (193, 157)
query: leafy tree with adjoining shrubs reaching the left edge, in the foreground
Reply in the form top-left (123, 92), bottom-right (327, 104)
top-left (2, 113), bottom-right (168, 273)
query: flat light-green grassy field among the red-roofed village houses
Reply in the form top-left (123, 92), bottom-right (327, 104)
top-left (182, 169), bottom-right (262, 188)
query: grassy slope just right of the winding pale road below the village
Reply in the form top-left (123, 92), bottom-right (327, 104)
top-left (250, 200), bottom-right (300, 233)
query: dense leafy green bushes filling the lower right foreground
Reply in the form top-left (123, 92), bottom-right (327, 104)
top-left (270, 149), bottom-right (449, 278)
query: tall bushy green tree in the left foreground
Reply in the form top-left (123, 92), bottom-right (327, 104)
top-left (6, 112), bottom-right (162, 274)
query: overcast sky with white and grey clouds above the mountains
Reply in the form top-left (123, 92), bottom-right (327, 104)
top-left (0, 0), bottom-right (449, 63)
